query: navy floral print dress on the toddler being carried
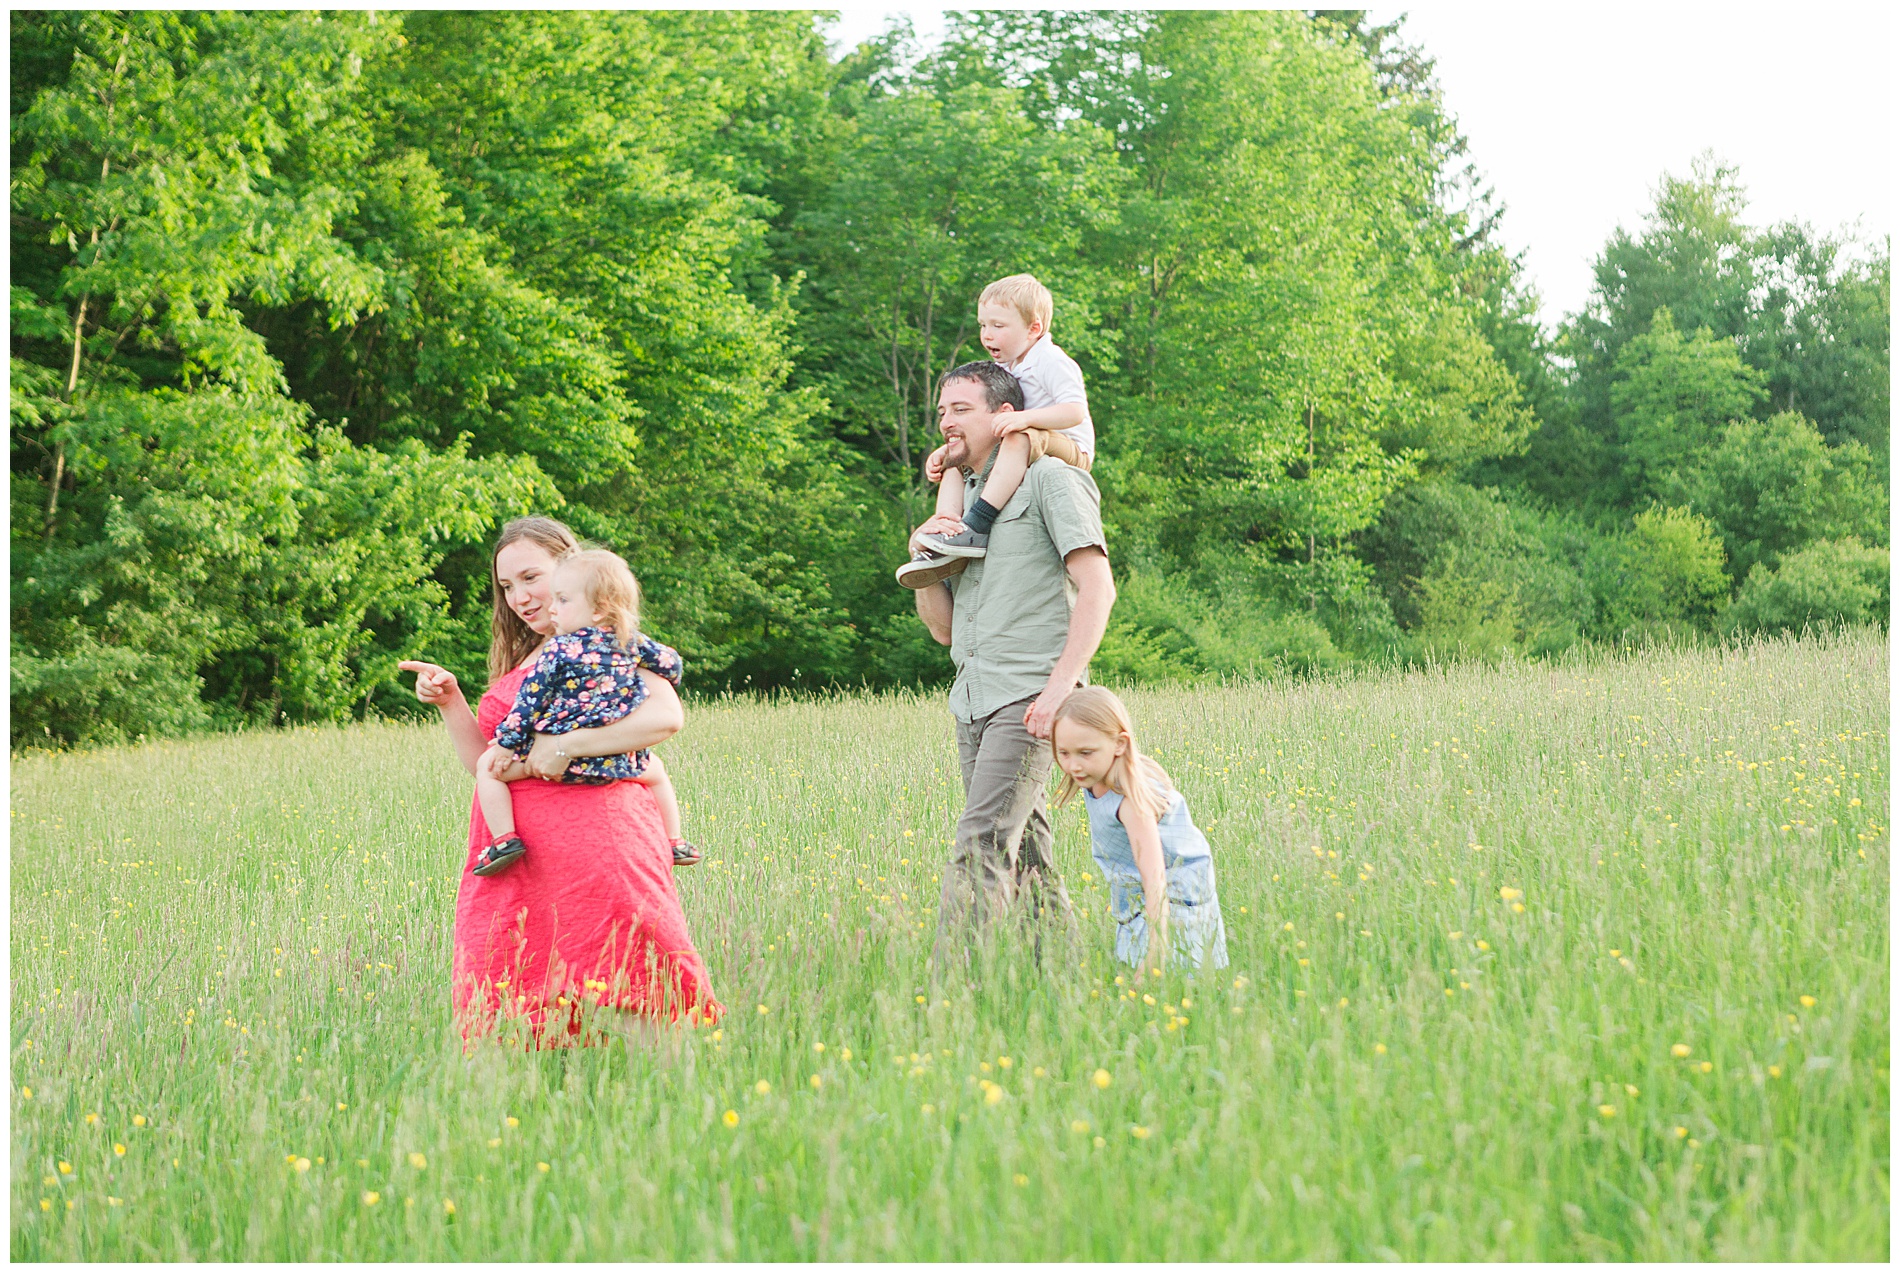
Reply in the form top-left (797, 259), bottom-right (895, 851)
top-left (494, 627), bottom-right (684, 783)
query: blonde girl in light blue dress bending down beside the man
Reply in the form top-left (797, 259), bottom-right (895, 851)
top-left (1049, 686), bottom-right (1227, 973)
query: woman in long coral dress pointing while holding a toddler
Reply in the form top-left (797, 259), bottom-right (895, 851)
top-left (401, 517), bottom-right (720, 1047)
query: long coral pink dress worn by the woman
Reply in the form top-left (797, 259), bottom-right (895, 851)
top-left (454, 667), bottom-right (722, 1047)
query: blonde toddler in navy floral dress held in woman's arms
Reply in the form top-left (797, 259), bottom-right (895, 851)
top-left (473, 549), bottom-right (699, 876)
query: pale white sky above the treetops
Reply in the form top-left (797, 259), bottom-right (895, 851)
top-left (832, 4), bottom-right (1894, 323)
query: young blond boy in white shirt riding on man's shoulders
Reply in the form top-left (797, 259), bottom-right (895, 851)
top-left (897, 274), bottom-right (1094, 587)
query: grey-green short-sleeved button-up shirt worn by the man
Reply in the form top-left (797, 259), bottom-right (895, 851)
top-left (948, 456), bottom-right (1108, 724)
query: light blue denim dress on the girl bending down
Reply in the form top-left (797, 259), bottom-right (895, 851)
top-left (1081, 787), bottom-right (1227, 969)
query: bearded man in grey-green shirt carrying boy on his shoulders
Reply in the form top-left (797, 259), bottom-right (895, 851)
top-left (912, 361), bottom-right (1115, 967)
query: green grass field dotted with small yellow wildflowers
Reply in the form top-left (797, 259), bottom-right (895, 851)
top-left (11, 633), bottom-right (1891, 1260)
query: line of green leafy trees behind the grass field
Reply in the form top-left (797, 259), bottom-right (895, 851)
top-left (10, 11), bottom-right (1891, 747)
